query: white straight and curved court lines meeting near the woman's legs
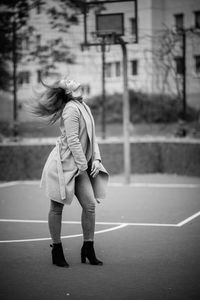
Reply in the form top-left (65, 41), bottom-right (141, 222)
top-left (0, 211), bottom-right (200, 244)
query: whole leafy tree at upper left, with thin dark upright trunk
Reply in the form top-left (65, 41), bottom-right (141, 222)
top-left (0, 0), bottom-right (83, 136)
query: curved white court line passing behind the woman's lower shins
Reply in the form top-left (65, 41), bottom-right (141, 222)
top-left (0, 223), bottom-right (128, 244)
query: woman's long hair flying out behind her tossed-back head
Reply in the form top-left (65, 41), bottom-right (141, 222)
top-left (30, 80), bottom-right (72, 124)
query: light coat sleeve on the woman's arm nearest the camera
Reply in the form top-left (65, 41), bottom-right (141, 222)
top-left (62, 107), bottom-right (88, 171)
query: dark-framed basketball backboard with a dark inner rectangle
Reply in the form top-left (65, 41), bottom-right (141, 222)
top-left (83, 0), bottom-right (138, 46)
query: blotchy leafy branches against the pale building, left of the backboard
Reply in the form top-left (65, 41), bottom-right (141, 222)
top-left (29, 0), bottom-right (83, 74)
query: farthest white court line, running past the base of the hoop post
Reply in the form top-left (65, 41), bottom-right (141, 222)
top-left (0, 180), bottom-right (200, 188)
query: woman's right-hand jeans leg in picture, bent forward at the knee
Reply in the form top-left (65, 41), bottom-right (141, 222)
top-left (75, 171), bottom-right (95, 241)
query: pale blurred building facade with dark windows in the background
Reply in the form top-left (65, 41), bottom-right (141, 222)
top-left (6, 0), bottom-right (200, 122)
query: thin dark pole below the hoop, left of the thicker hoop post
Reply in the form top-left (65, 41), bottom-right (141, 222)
top-left (101, 39), bottom-right (106, 139)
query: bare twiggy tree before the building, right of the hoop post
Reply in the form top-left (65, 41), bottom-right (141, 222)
top-left (145, 28), bottom-right (183, 100)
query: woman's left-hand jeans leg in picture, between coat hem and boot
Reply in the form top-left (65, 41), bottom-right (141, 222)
top-left (48, 200), bottom-right (64, 244)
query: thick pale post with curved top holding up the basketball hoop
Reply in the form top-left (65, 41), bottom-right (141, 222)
top-left (120, 39), bottom-right (131, 184)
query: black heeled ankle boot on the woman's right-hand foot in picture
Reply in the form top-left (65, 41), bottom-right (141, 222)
top-left (81, 241), bottom-right (103, 265)
